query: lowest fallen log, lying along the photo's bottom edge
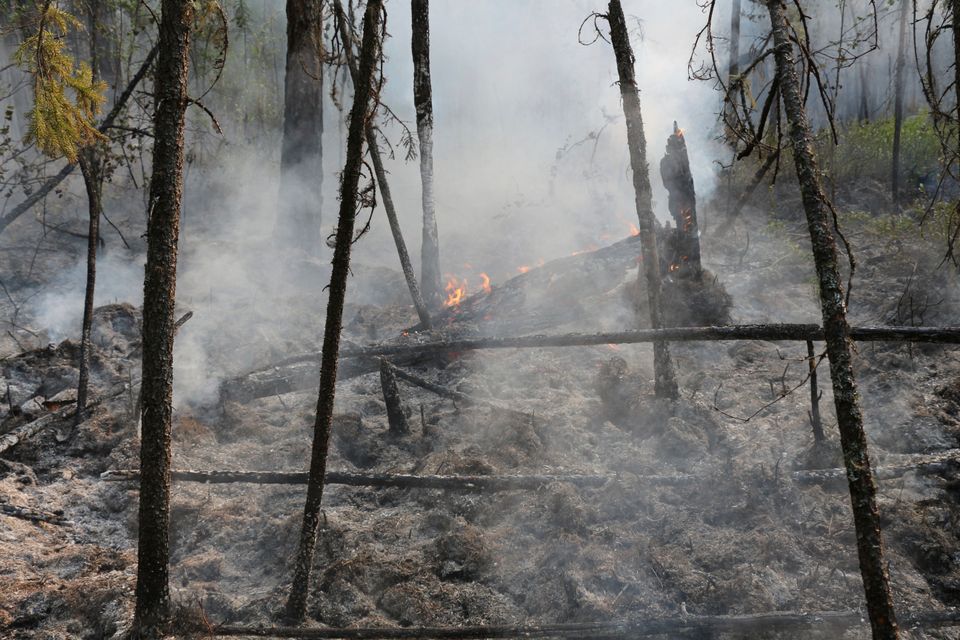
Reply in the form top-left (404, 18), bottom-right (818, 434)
top-left (202, 610), bottom-right (960, 640)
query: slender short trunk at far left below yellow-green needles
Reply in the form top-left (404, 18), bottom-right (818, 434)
top-left (75, 145), bottom-right (103, 424)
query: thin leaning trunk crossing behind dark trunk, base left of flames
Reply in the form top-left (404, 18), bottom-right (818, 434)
top-left (333, 0), bottom-right (433, 329)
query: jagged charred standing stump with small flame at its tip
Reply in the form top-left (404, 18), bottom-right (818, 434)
top-left (660, 122), bottom-right (702, 277)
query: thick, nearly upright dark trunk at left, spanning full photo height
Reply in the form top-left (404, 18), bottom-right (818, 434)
top-left (135, 0), bottom-right (195, 638)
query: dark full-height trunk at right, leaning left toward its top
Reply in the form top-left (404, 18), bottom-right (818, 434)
top-left (767, 0), bottom-right (899, 639)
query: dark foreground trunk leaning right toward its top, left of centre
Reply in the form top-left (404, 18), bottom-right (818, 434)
top-left (285, 0), bottom-right (383, 621)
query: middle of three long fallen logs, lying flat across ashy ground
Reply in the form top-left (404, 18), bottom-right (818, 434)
top-left (100, 449), bottom-right (960, 491)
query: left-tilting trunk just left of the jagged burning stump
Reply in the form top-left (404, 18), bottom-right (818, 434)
top-left (607, 0), bottom-right (678, 398)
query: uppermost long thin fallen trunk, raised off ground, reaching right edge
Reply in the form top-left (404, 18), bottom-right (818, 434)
top-left (336, 324), bottom-right (960, 362)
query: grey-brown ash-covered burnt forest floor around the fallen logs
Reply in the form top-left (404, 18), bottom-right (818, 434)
top-left (0, 189), bottom-right (960, 639)
